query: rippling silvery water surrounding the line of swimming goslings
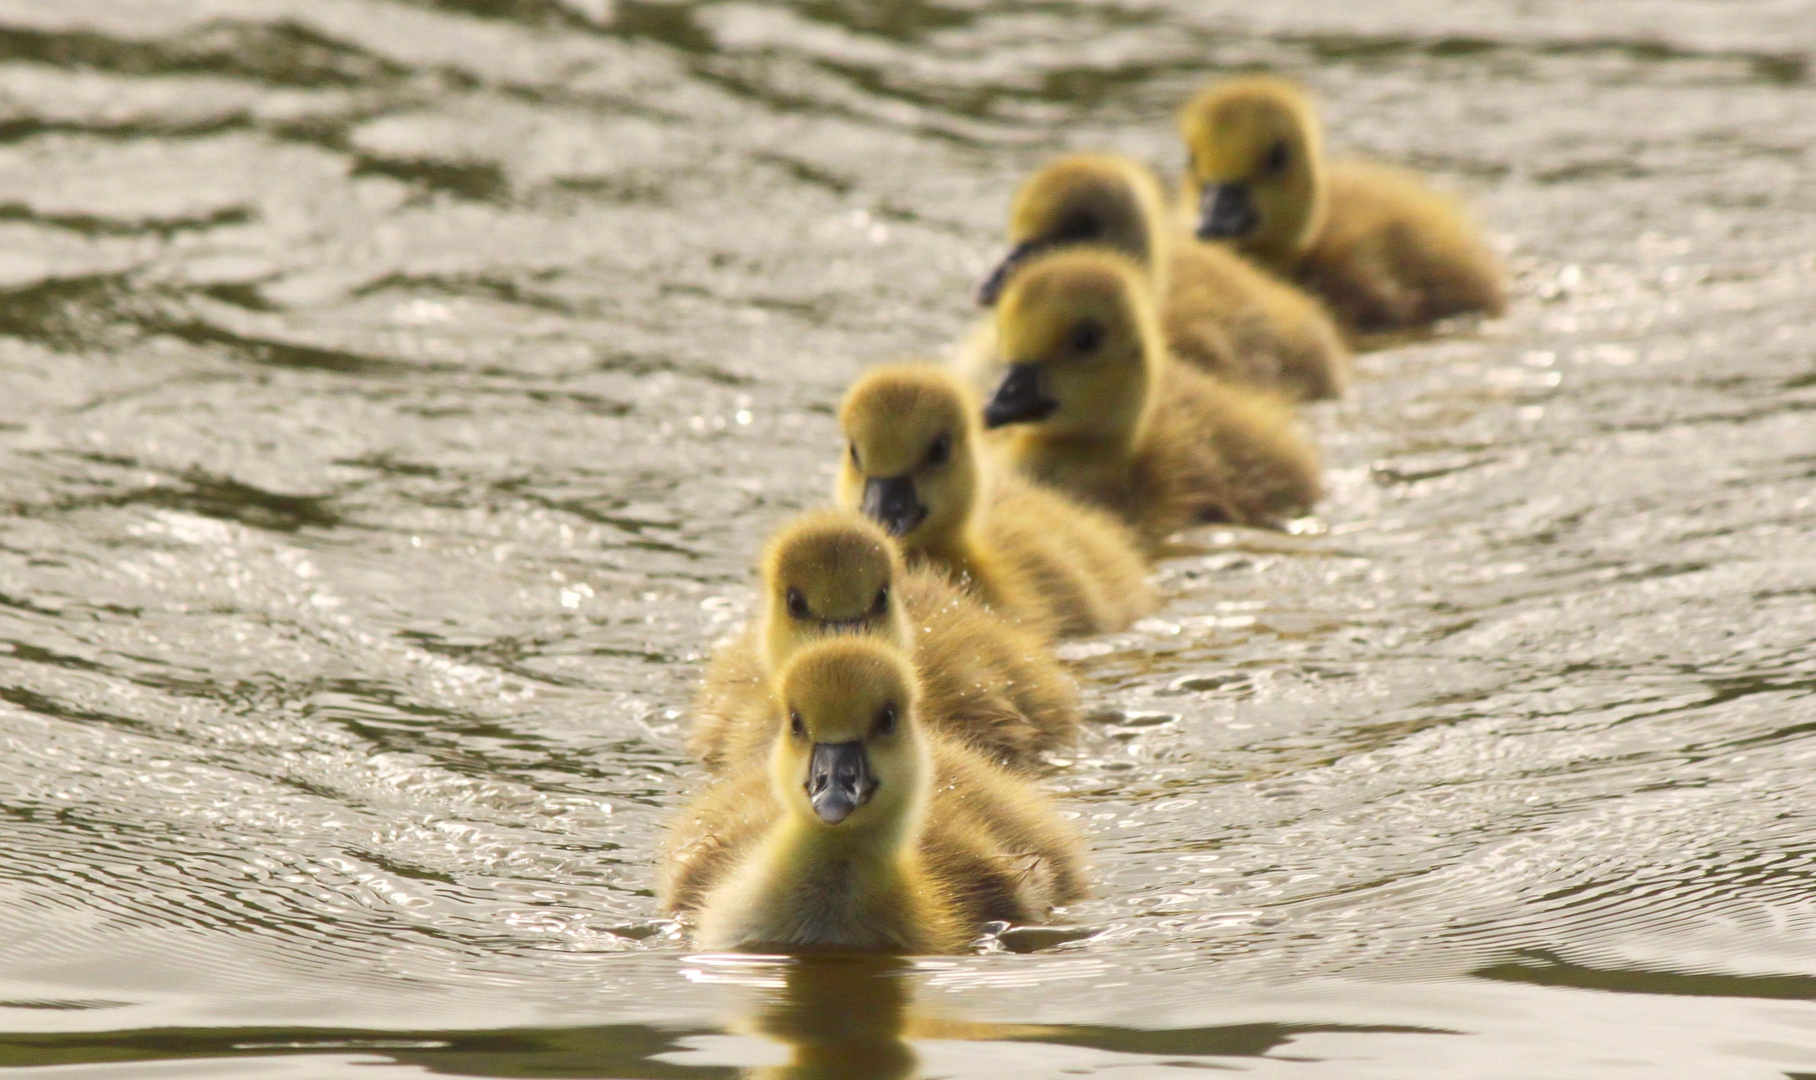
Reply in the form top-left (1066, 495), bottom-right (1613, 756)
top-left (0, 0), bottom-right (1816, 1080)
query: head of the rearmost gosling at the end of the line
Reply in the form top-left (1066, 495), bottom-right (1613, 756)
top-left (1179, 76), bottom-right (1324, 260)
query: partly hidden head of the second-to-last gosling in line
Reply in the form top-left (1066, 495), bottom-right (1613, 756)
top-left (977, 154), bottom-right (1166, 307)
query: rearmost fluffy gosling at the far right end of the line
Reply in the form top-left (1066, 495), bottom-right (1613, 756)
top-left (1179, 76), bottom-right (1507, 330)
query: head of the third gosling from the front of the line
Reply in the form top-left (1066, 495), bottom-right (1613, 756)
top-left (835, 365), bottom-right (979, 552)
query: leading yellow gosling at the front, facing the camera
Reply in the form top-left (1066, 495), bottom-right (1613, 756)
top-left (661, 637), bottom-right (1084, 953)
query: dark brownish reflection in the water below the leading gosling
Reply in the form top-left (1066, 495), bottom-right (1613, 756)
top-left (741, 955), bottom-right (919, 1080)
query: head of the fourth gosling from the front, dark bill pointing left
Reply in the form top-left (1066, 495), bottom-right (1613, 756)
top-left (984, 249), bottom-right (1162, 439)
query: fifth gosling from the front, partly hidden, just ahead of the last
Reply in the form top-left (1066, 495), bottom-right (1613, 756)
top-left (977, 154), bottom-right (1349, 399)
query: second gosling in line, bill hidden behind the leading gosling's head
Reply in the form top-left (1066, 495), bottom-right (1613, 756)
top-left (688, 510), bottom-right (1079, 771)
